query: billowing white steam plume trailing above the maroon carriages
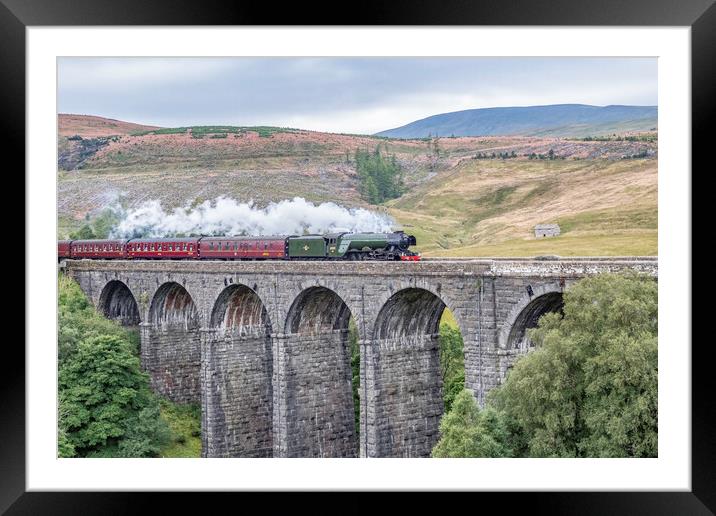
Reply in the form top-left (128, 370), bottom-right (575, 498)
top-left (112, 197), bottom-right (395, 238)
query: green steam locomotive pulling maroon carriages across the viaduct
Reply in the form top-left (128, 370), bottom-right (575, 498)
top-left (57, 231), bottom-right (420, 261)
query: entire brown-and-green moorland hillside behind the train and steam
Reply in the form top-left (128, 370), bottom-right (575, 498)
top-left (58, 118), bottom-right (657, 256)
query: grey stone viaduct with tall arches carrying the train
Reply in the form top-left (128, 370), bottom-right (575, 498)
top-left (61, 257), bottom-right (658, 457)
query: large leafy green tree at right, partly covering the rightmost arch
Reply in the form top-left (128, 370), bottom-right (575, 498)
top-left (489, 274), bottom-right (658, 457)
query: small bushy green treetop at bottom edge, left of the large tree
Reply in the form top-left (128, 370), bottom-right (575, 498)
top-left (432, 389), bottom-right (512, 458)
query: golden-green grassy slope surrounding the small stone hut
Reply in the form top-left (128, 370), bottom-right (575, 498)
top-left (387, 159), bottom-right (657, 256)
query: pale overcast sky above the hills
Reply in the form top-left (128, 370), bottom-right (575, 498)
top-left (57, 57), bottom-right (657, 134)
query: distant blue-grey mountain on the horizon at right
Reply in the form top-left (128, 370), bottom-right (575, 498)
top-left (376, 104), bottom-right (657, 138)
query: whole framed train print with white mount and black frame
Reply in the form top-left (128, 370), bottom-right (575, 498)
top-left (0, 0), bottom-right (716, 514)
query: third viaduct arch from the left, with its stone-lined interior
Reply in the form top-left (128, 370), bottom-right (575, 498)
top-left (201, 283), bottom-right (273, 457)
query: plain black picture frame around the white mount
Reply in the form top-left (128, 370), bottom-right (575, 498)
top-left (0, 0), bottom-right (716, 515)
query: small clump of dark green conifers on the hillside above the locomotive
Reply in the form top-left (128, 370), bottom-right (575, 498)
top-left (355, 144), bottom-right (404, 204)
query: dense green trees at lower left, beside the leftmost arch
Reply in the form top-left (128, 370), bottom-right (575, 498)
top-left (58, 276), bottom-right (169, 457)
